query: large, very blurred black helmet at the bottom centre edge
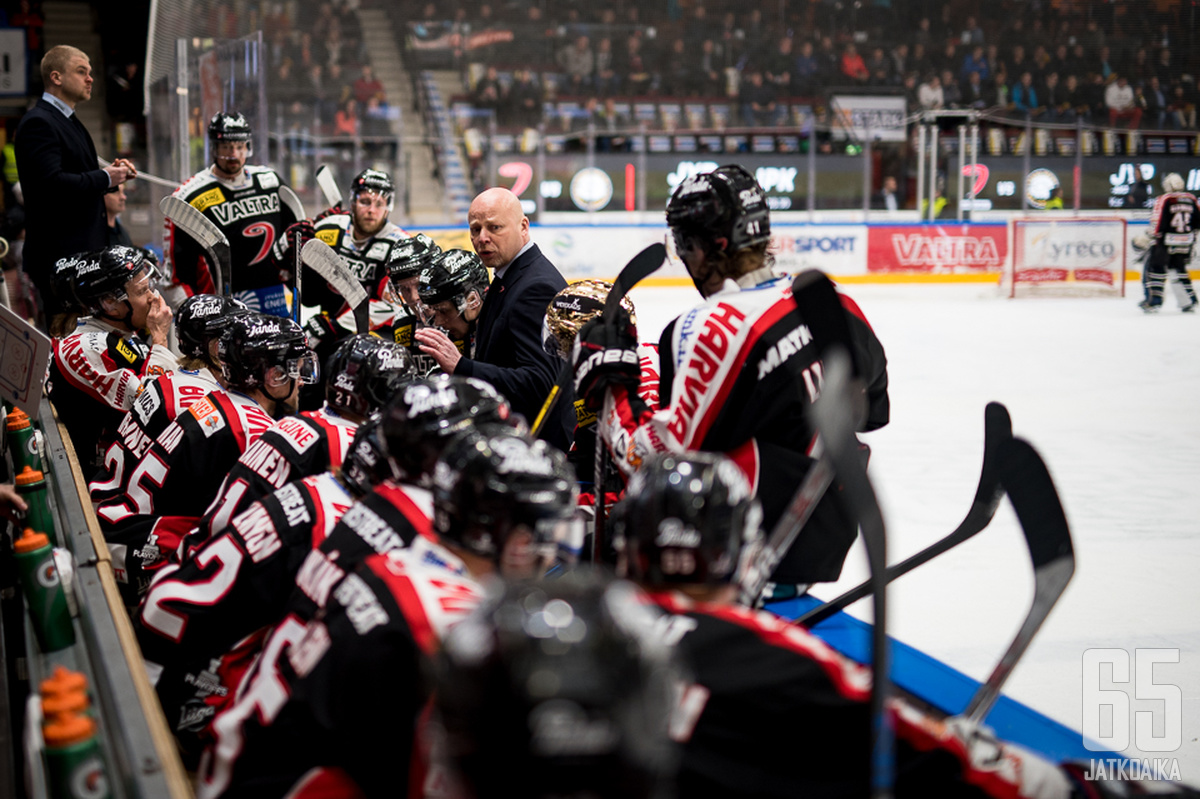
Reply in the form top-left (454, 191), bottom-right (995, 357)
top-left (434, 572), bottom-right (682, 799)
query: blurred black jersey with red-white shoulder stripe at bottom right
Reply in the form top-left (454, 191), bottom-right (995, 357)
top-left (653, 593), bottom-right (1070, 799)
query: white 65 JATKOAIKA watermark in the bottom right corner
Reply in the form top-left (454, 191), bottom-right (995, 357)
top-left (1084, 649), bottom-right (1183, 780)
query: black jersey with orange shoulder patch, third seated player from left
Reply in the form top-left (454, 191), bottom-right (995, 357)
top-left (96, 390), bottom-right (275, 607)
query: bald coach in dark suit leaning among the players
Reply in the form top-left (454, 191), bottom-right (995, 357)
top-left (418, 188), bottom-right (575, 451)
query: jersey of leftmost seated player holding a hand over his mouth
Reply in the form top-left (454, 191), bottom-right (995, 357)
top-left (49, 317), bottom-right (178, 474)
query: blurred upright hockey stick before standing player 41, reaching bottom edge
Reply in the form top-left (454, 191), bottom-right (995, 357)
top-left (812, 350), bottom-right (895, 798)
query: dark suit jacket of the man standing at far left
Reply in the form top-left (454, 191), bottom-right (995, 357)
top-left (13, 100), bottom-right (108, 314)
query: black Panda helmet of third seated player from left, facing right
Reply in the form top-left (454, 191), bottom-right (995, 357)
top-left (217, 311), bottom-right (320, 389)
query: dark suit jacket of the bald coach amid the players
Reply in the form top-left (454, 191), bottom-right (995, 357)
top-left (455, 245), bottom-right (575, 452)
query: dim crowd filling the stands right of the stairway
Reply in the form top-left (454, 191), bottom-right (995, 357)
top-left (398, 0), bottom-right (1198, 130)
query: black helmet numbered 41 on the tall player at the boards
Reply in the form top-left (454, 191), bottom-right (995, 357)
top-left (667, 164), bottom-right (770, 254)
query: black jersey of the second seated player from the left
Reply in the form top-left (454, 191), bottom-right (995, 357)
top-left (88, 368), bottom-right (222, 505)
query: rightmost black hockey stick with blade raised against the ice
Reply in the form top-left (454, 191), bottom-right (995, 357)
top-left (962, 438), bottom-right (1075, 723)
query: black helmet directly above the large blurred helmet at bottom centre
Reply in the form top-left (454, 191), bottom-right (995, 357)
top-left (433, 427), bottom-right (582, 565)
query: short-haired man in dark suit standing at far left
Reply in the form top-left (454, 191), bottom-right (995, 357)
top-left (13, 44), bottom-right (137, 318)
